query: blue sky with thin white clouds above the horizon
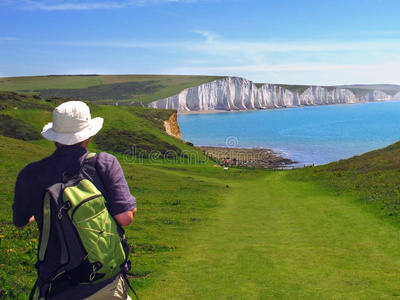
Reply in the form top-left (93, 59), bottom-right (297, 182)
top-left (0, 0), bottom-right (400, 85)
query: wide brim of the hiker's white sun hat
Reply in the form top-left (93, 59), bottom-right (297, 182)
top-left (42, 118), bottom-right (104, 145)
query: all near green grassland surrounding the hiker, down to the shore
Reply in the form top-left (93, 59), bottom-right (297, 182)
top-left (0, 93), bottom-right (400, 300)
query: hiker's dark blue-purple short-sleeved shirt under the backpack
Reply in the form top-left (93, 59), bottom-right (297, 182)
top-left (13, 145), bottom-right (136, 300)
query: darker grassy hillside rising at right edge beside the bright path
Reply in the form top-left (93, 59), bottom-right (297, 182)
top-left (292, 142), bottom-right (400, 222)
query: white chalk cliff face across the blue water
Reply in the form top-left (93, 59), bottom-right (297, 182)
top-left (149, 77), bottom-right (394, 111)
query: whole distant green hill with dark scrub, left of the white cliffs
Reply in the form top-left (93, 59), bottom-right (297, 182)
top-left (0, 75), bottom-right (223, 106)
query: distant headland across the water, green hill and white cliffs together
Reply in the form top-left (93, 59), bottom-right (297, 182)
top-left (0, 74), bottom-right (400, 112)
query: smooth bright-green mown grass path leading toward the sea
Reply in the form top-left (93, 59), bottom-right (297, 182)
top-left (137, 166), bottom-right (400, 299)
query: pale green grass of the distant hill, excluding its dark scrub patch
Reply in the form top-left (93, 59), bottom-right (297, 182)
top-left (0, 75), bottom-right (223, 103)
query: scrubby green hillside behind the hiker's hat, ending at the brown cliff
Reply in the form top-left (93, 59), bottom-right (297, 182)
top-left (0, 92), bottom-right (202, 157)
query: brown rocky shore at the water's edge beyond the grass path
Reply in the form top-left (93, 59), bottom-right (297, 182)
top-left (197, 146), bottom-right (296, 169)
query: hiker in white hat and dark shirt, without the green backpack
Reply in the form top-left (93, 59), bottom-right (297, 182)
top-left (13, 101), bottom-right (137, 300)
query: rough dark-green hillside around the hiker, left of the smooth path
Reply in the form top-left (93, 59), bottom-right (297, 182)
top-left (0, 92), bottom-right (214, 299)
